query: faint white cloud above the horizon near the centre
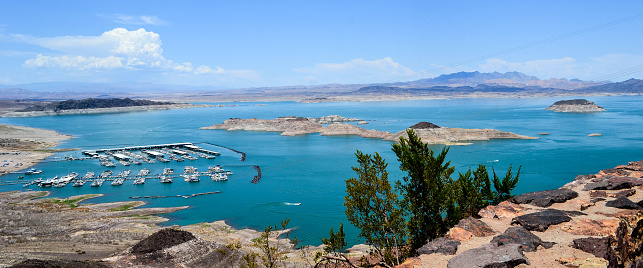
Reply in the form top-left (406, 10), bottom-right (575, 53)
top-left (294, 57), bottom-right (415, 83)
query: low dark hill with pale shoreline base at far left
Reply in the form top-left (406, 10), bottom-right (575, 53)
top-left (3, 98), bottom-right (211, 117)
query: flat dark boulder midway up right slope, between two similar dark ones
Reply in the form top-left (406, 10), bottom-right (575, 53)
top-left (511, 209), bottom-right (587, 232)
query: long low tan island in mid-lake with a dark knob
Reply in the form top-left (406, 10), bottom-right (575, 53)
top-left (200, 115), bottom-right (538, 145)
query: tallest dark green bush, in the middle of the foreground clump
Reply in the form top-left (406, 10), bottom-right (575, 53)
top-left (393, 129), bottom-right (455, 253)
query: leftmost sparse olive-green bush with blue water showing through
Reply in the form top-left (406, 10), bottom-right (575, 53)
top-left (344, 150), bottom-right (406, 266)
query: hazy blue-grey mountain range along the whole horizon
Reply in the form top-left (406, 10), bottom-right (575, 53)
top-left (0, 71), bottom-right (643, 101)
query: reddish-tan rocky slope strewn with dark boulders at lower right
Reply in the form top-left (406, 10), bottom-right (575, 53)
top-left (403, 161), bottom-right (643, 268)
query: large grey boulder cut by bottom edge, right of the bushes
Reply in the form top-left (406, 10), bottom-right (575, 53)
top-left (447, 244), bottom-right (528, 268)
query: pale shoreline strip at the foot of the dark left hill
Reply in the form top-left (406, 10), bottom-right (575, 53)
top-left (2, 103), bottom-right (213, 117)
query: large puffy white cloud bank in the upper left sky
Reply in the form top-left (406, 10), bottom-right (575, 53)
top-left (10, 28), bottom-right (259, 82)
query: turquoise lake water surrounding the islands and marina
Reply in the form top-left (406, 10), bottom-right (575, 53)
top-left (0, 96), bottom-right (643, 244)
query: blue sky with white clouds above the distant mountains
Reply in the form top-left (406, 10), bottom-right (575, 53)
top-left (0, 0), bottom-right (643, 88)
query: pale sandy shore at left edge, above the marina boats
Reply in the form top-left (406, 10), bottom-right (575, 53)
top-left (0, 124), bottom-right (72, 175)
